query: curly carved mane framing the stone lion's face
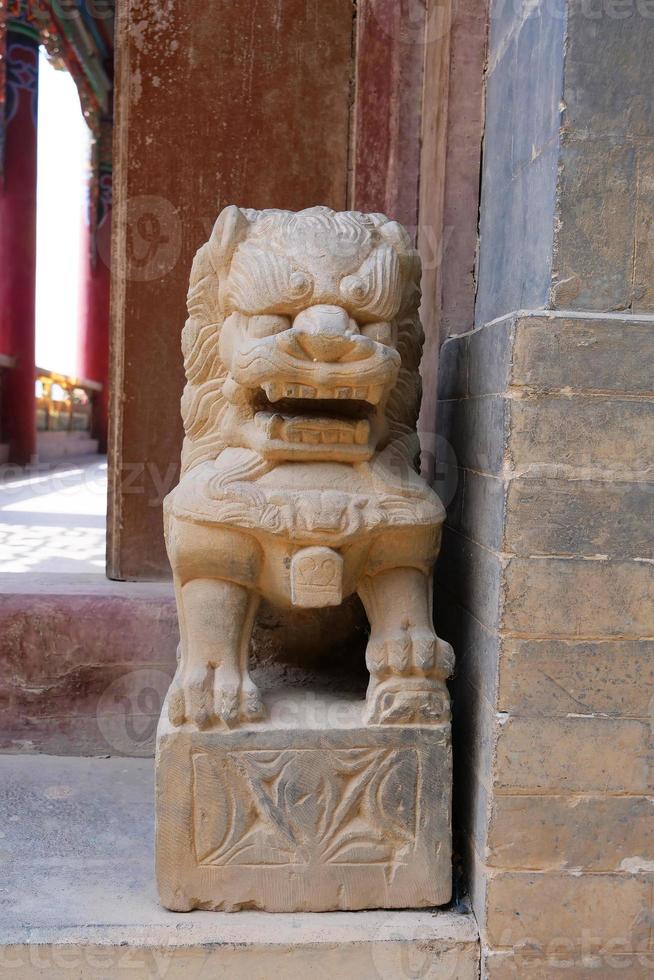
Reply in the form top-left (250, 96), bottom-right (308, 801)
top-left (181, 205), bottom-right (424, 473)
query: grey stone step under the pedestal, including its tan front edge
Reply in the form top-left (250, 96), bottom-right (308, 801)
top-left (0, 755), bottom-right (479, 980)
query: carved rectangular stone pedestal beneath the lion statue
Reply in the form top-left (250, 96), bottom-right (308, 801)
top-left (156, 691), bottom-right (451, 912)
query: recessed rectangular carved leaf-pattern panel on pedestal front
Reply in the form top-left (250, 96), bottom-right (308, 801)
top-left (193, 748), bottom-right (419, 867)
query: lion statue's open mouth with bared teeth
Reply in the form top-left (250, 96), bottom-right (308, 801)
top-left (254, 382), bottom-right (383, 446)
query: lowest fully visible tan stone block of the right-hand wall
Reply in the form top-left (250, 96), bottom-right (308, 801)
top-left (486, 871), bottom-right (654, 952)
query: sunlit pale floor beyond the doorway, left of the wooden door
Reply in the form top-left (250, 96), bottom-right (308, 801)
top-left (0, 456), bottom-right (107, 575)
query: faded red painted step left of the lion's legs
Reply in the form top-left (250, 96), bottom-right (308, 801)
top-left (0, 575), bottom-right (179, 755)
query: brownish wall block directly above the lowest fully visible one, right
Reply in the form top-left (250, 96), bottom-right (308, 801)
top-left (486, 794), bottom-right (654, 873)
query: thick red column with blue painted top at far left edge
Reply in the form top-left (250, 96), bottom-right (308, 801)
top-left (0, 23), bottom-right (39, 465)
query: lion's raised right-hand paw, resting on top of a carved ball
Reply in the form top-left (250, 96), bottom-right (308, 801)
top-left (366, 626), bottom-right (454, 680)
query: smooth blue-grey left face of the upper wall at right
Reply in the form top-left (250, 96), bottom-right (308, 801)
top-left (476, 0), bottom-right (565, 323)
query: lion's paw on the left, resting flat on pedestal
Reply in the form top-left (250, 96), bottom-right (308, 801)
top-left (168, 664), bottom-right (264, 729)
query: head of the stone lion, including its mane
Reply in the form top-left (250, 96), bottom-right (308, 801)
top-left (182, 205), bottom-right (423, 472)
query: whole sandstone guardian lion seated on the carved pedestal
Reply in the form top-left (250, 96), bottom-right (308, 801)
top-left (165, 206), bottom-right (452, 728)
